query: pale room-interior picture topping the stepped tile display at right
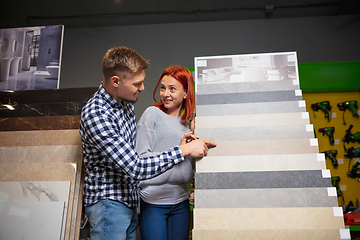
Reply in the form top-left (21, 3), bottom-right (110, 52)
top-left (195, 52), bottom-right (299, 93)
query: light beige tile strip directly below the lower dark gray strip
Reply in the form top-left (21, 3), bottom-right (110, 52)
top-left (195, 187), bottom-right (338, 208)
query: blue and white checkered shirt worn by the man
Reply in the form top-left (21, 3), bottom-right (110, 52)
top-left (80, 86), bottom-right (184, 207)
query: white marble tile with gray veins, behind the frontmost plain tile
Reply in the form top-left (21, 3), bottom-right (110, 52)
top-left (0, 181), bottom-right (70, 239)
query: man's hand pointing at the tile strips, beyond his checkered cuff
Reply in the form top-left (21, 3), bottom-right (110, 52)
top-left (180, 133), bottom-right (216, 158)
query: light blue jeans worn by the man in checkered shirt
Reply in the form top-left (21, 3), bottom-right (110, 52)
top-left (85, 200), bottom-right (137, 240)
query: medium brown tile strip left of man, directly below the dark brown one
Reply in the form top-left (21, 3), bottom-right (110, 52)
top-left (0, 129), bottom-right (81, 147)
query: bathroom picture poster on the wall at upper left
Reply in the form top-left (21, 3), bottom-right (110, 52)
top-left (0, 25), bottom-right (64, 91)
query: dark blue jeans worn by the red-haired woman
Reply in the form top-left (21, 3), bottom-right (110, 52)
top-left (139, 200), bottom-right (190, 240)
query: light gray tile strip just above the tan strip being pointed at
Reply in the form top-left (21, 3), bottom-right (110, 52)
top-left (195, 125), bottom-right (314, 142)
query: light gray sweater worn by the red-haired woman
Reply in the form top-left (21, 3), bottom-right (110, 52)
top-left (136, 107), bottom-right (194, 204)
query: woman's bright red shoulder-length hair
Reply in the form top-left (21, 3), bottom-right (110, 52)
top-left (153, 66), bottom-right (195, 122)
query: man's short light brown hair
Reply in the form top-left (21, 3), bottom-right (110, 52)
top-left (102, 46), bottom-right (149, 81)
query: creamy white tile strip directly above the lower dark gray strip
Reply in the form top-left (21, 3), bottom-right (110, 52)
top-left (196, 154), bottom-right (326, 173)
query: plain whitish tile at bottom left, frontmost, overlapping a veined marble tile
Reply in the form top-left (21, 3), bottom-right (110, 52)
top-left (0, 202), bottom-right (64, 240)
